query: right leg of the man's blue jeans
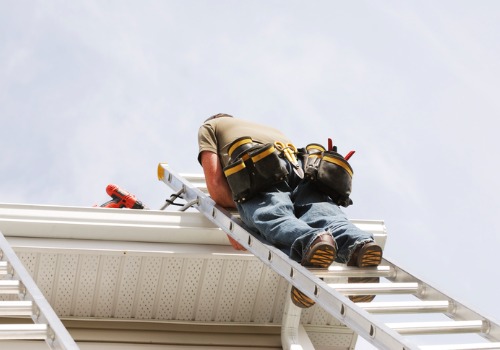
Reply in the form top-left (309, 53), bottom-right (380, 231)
top-left (293, 180), bottom-right (373, 263)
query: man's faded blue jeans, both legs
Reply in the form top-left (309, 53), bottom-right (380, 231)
top-left (237, 162), bottom-right (373, 263)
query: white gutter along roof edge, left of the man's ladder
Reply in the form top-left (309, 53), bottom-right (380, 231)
top-left (0, 204), bottom-right (228, 245)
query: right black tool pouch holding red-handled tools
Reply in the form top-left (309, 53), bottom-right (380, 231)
top-left (303, 143), bottom-right (353, 207)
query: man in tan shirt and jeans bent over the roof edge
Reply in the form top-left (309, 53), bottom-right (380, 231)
top-left (198, 114), bottom-right (382, 308)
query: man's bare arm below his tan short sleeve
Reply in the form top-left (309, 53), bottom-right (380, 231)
top-left (200, 151), bottom-right (246, 250)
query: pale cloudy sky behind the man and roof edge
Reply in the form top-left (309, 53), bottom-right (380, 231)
top-left (0, 0), bottom-right (500, 348)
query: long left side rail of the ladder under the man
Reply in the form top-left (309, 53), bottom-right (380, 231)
top-left (158, 163), bottom-right (418, 350)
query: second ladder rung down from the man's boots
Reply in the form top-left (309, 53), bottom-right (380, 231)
top-left (328, 282), bottom-right (418, 295)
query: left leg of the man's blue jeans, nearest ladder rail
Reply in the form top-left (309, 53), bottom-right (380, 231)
top-left (237, 182), bottom-right (322, 262)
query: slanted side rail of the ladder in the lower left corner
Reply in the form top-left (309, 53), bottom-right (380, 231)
top-left (0, 231), bottom-right (78, 349)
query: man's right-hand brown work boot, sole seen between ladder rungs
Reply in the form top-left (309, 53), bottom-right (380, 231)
top-left (347, 242), bottom-right (382, 303)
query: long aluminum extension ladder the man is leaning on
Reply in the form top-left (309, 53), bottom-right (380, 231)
top-left (158, 163), bottom-right (500, 350)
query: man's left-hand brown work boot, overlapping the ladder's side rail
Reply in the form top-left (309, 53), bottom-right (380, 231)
top-left (291, 232), bottom-right (336, 309)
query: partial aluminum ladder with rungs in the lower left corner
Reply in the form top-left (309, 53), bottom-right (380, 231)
top-left (0, 232), bottom-right (78, 349)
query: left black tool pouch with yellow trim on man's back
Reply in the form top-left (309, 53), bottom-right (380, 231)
top-left (224, 137), bottom-right (288, 202)
